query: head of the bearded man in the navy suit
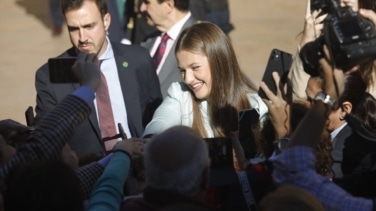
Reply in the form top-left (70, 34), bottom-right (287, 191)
top-left (65, 1), bottom-right (111, 57)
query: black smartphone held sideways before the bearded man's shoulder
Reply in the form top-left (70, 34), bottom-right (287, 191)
top-left (48, 57), bottom-right (78, 83)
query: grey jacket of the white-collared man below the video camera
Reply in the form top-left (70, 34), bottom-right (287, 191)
top-left (330, 125), bottom-right (352, 178)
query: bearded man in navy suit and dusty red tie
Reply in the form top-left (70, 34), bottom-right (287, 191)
top-left (35, 0), bottom-right (162, 157)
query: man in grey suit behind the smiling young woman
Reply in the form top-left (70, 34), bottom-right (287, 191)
top-left (140, 0), bottom-right (197, 97)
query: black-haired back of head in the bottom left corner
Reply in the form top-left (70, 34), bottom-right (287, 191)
top-left (3, 161), bottom-right (84, 211)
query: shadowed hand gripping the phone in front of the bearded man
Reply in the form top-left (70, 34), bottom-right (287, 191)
top-left (72, 52), bottom-right (100, 92)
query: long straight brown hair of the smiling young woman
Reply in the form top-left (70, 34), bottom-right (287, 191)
top-left (175, 22), bottom-right (256, 137)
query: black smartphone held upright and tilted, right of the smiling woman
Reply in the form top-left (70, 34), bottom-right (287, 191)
top-left (258, 49), bottom-right (293, 99)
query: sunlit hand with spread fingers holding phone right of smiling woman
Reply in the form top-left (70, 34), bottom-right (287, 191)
top-left (260, 72), bottom-right (290, 138)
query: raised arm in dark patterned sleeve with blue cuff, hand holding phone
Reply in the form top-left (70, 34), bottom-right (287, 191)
top-left (0, 54), bottom-right (99, 177)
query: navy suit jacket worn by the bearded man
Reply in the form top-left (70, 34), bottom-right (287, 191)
top-left (35, 43), bottom-right (162, 156)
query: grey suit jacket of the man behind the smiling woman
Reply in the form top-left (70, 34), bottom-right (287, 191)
top-left (141, 16), bottom-right (197, 97)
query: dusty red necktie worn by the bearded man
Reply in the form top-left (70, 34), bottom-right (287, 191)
top-left (96, 72), bottom-right (117, 152)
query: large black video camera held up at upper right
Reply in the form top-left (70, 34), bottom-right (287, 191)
top-left (299, 0), bottom-right (376, 76)
